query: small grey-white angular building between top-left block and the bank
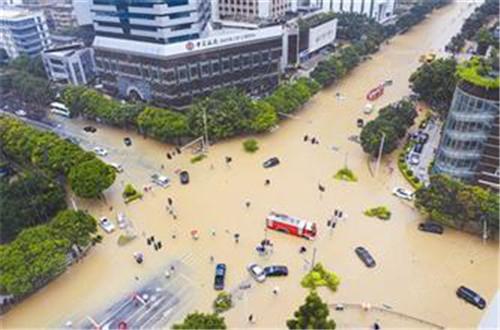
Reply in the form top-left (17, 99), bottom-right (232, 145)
top-left (42, 44), bottom-right (96, 85)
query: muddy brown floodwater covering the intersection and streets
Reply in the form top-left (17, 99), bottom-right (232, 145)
top-left (1, 1), bottom-right (498, 329)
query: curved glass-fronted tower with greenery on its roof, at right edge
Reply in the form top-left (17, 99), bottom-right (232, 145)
top-left (434, 58), bottom-right (500, 191)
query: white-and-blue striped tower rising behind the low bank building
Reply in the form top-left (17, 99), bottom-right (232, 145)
top-left (92, 0), bottom-right (211, 44)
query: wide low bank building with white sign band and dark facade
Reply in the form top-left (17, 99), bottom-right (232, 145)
top-left (94, 26), bottom-right (285, 109)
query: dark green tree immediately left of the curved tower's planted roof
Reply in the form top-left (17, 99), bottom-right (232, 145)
top-left (410, 58), bottom-right (457, 118)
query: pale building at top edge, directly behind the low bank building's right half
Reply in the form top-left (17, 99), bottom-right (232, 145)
top-left (217, 0), bottom-right (295, 20)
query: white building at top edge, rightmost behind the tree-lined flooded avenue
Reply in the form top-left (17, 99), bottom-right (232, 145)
top-left (309, 0), bottom-right (396, 23)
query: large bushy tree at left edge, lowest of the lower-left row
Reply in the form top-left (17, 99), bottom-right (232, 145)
top-left (0, 225), bottom-right (70, 296)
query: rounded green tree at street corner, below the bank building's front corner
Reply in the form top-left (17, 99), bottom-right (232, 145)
top-left (137, 107), bottom-right (189, 141)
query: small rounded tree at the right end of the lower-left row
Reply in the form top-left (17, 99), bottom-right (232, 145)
top-left (50, 210), bottom-right (97, 249)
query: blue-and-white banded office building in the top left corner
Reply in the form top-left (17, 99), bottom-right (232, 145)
top-left (0, 8), bottom-right (51, 59)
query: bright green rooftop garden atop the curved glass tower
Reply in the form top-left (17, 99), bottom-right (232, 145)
top-left (457, 57), bottom-right (500, 89)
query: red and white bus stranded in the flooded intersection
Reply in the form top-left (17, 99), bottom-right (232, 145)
top-left (266, 212), bottom-right (316, 240)
